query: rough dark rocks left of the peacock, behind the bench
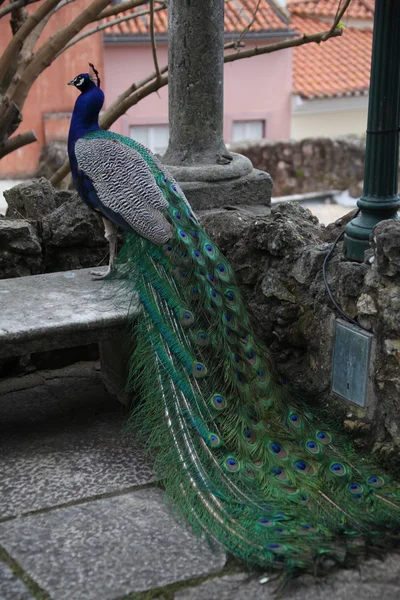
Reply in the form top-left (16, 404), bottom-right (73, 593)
top-left (0, 177), bottom-right (108, 279)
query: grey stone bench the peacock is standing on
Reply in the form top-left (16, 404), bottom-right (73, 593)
top-left (0, 269), bottom-right (140, 401)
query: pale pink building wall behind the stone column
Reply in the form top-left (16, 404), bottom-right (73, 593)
top-left (104, 40), bottom-right (292, 141)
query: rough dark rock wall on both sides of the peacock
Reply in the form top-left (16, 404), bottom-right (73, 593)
top-left (0, 179), bottom-right (400, 453)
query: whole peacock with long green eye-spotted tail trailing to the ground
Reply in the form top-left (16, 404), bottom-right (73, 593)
top-left (68, 65), bottom-right (400, 577)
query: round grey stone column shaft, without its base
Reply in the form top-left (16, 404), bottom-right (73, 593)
top-left (165, 0), bottom-right (228, 167)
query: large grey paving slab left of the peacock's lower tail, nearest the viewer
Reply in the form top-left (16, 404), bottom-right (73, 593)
top-left (0, 489), bottom-right (226, 600)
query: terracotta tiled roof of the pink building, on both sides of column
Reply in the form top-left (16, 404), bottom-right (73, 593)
top-left (105, 0), bottom-right (288, 37)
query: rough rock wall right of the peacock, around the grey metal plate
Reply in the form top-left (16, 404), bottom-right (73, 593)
top-left (201, 203), bottom-right (400, 455)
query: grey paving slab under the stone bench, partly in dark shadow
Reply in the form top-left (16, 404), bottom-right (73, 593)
top-left (0, 367), bottom-right (155, 518)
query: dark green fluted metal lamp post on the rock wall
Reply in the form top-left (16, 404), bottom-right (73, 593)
top-left (345, 0), bottom-right (400, 262)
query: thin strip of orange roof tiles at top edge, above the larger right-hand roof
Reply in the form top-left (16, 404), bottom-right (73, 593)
top-left (287, 0), bottom-right (375, 22)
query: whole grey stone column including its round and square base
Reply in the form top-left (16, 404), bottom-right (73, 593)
top-left (163, 0), bottom-right (272, 210)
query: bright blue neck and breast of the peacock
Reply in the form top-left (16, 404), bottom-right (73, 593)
top-left (68, 84), bottom-right (104, 179)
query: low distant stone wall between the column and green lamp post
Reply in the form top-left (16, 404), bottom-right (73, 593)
top-left (231, 137), bottom-right (365, 197)
